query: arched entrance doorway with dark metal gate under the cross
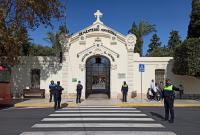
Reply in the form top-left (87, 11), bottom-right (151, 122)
top-left (85, 55), bottom-right (110, 98)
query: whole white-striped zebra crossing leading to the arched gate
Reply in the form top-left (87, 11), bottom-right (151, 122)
top-left (20, 106), bottom-right (176, 135)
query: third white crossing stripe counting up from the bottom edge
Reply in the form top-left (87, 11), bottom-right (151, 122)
top-left (42, 118), bottom-right (154, 121)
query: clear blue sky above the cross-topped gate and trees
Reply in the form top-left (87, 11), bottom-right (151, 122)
top-left (29, 0), bottom-right (192, 53)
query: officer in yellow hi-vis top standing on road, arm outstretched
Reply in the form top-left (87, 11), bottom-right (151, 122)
top-left (163, 79), bottom-right (178, 123)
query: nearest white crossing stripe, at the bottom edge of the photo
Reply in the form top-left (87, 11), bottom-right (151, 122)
top-left (20, 131), bottom-right (176, 135)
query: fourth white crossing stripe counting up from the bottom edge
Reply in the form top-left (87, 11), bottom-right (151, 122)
top-left (49, 113), bottom-right (147, 117)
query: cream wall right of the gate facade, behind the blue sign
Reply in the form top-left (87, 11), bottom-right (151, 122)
top-left (131, 54), bottom-right (200, 95)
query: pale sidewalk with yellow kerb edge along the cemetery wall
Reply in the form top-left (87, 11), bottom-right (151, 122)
top-left (14, 98), bottom-right (200, 108)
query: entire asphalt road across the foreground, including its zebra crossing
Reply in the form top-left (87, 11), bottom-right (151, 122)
top-left (0, 107), bottom-right (200, 135)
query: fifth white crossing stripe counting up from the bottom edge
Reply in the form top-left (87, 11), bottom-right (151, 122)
top-left (56, 110), bottom-right (141, 113)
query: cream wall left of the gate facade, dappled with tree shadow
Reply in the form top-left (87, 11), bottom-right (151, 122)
top-left (11, 57), bottom-right (62, 94)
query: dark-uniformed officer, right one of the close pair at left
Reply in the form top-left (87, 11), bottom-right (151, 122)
top-left (54, 81), bottom-right (64, 110)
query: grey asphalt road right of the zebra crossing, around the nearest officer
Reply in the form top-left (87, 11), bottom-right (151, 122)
top-left (138, 107), bottom-right (200, 135)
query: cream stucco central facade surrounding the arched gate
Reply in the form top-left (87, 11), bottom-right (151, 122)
top-left (66, 22), bottom-right (128, 97)
